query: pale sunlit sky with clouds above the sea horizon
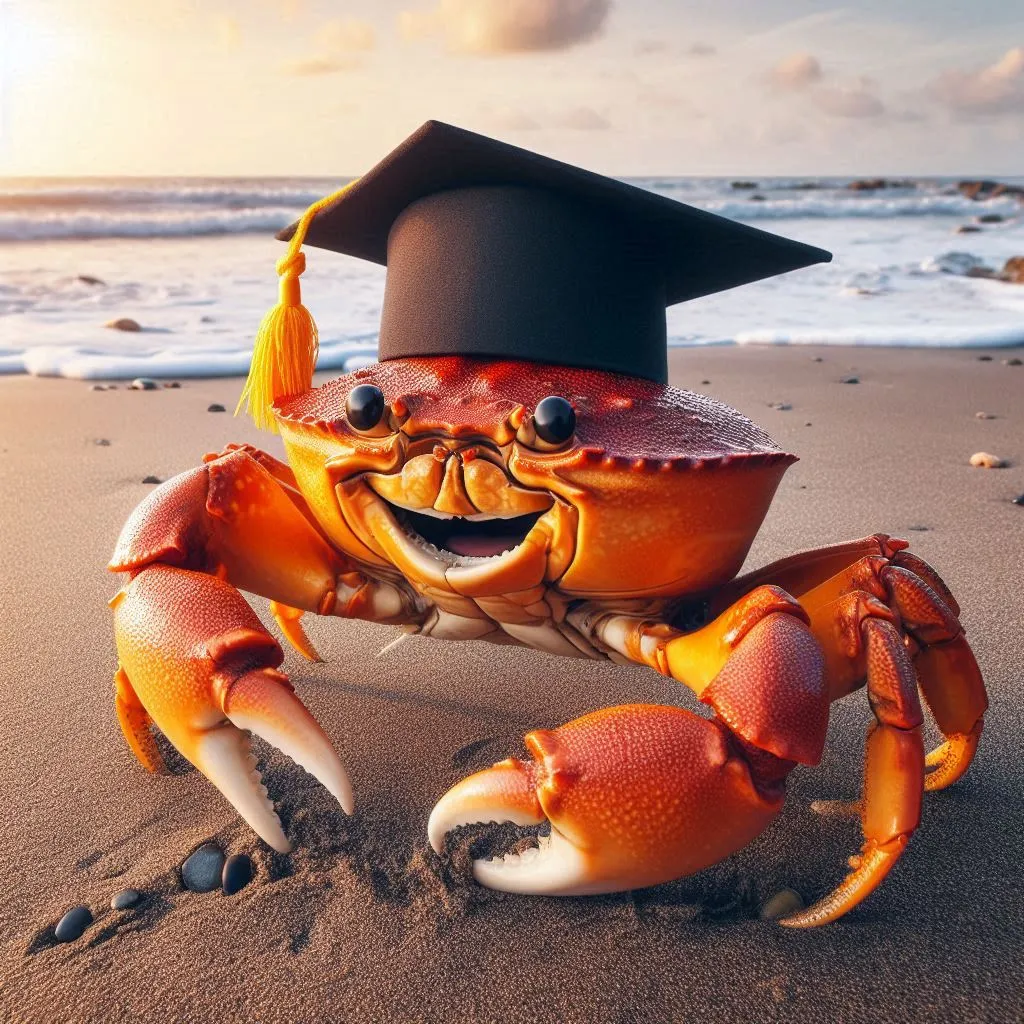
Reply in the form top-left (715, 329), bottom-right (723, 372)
top-left (0, 0), bottom-right (1024, 177)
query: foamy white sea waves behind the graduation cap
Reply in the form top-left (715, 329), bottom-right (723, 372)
top-left (0, 177), bottom-right (1024, 379)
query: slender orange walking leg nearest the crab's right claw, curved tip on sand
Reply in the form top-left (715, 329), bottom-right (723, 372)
top-left (779, 610), bottom-right (925, 928)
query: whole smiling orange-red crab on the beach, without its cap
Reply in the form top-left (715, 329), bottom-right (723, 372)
top-left (110, 356), bottom-right (987, 928)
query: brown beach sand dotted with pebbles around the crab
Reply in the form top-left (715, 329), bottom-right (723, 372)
top-left (0, 348), bottom-right (1024, 1024)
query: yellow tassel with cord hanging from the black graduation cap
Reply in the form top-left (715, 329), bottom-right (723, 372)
top-left (234, 182), bottom-right (354, 433)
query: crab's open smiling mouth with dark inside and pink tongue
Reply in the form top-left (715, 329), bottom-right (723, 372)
top-left (381, 498), bottom-right (546, 564)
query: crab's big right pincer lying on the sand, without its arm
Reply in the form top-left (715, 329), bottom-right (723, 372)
top-left (427, 705), bottom-right (782, 896)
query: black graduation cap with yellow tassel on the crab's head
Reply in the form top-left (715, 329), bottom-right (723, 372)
top-left (239, 121), bottom-right (831, 429)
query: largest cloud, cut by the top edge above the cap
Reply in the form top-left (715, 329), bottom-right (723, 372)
top-left (398, 0), bottom-right (611, 53)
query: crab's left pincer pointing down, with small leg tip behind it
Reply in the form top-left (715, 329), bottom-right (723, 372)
top-left (112, 565), bottom-right (352, 852)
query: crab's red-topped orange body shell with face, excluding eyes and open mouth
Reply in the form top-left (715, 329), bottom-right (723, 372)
top-left (275, 356), bottom-right (796, 604)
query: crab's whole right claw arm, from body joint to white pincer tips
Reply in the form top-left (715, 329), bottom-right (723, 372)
top-left (428, 589), bottom-right (828, 895)
